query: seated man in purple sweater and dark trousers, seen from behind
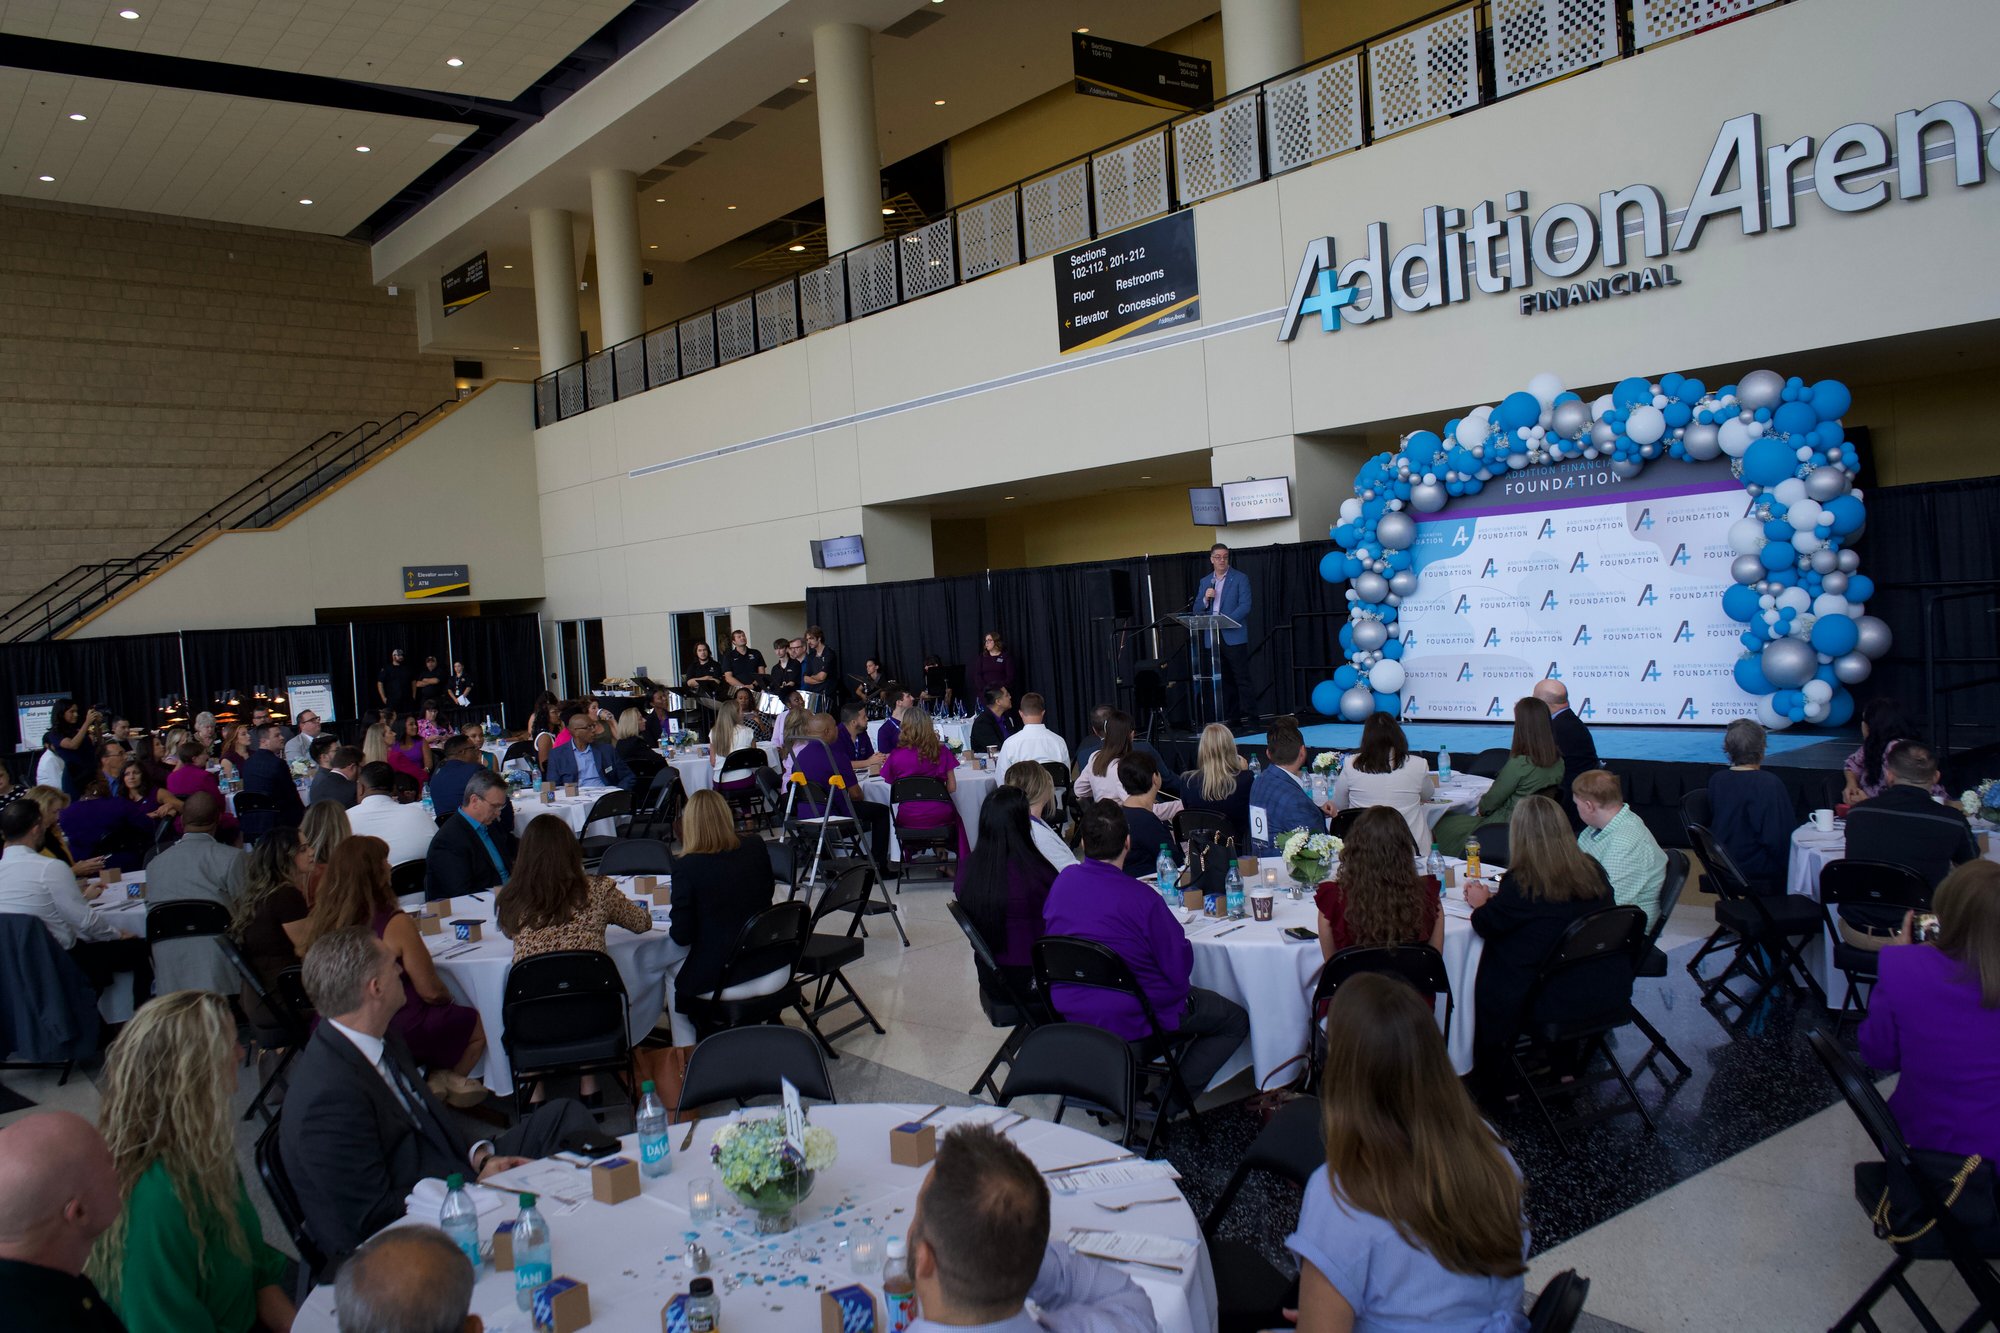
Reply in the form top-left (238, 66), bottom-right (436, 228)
top-left (1042, 801), bottom-right (1250, 1113)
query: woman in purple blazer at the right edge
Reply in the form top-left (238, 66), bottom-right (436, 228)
top-left (1860, 861), bottom-right (2000, 1159)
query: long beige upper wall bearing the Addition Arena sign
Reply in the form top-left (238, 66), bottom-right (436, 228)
top-left (536, 0), bottom-right (2000, 660)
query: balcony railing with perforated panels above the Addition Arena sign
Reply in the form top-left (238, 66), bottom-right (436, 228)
top-left (534, 0), bottom-right (1792, 426)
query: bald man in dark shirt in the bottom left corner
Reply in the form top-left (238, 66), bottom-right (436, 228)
top-left (0, 1111), bottom-right (124, 1333)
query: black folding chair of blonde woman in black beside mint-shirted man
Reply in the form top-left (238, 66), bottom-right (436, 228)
top-left (1512, 907), bottom-right (1654, 1151)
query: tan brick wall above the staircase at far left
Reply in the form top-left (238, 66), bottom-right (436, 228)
top-left (0, 198), bottom-right (452, 600)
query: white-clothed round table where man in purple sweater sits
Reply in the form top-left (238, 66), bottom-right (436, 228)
top-left (1184, 859), bottom-right (1492, 1087)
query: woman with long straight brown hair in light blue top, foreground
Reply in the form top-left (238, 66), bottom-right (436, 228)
top-left (1286, 964), bottom-right (1528, 1333)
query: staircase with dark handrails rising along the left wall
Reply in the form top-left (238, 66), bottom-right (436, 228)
top-left (0, 398), bottom-right (456, 642)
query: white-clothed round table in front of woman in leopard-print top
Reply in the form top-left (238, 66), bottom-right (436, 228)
top-left (424, 877), bottom-right (694, 1095)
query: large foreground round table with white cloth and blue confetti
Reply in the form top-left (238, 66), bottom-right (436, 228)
top-left (292, 1105), bottom-right (1216, 1333)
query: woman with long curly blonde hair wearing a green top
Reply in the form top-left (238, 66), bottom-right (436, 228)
top-left (86, 991), bottom-right (296, 1333)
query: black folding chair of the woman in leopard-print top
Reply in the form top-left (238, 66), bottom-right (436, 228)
top-left (500, 949), bottom-right (638, 1107)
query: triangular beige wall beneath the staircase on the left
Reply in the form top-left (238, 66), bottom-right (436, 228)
top-left (78, 384), bottom-right (542, 638)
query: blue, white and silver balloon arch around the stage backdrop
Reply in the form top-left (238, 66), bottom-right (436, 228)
top-left (1312, 370), bottom-right (1890, 731)
